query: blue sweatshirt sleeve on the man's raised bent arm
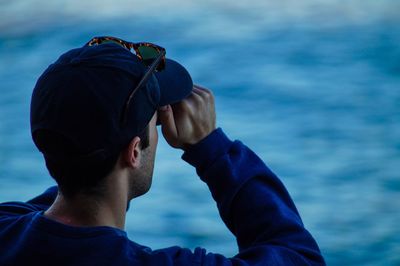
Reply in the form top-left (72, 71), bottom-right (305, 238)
top-left (182, 128), bottom-right (325, 265)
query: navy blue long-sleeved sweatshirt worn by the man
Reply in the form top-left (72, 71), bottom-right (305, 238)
top-left (0, 129), bottom-right (325, 265)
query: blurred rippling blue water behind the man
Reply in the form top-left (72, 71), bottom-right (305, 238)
top-left (0, 0), bottom-right (400, 265)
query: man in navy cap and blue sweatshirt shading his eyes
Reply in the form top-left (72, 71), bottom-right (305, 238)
top-left (0, 37), bottom-right (324, 265)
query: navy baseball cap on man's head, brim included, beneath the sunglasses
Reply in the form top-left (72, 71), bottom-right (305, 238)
top-left (31, 43), bottom-right (193, 164)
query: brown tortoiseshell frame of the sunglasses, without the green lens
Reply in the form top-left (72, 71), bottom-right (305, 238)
top-left (85, 36), bottom-right (166, 126)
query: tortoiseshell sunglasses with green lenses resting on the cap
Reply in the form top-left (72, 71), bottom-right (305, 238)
top-left (85, 36), bottom-right (166, 126)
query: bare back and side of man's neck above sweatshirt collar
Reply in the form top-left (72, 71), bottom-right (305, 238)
top-left (44, 178), bottom-right (128, 230)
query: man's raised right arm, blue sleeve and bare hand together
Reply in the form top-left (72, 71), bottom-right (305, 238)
top-left (159, 86), bottom-right (324, 265)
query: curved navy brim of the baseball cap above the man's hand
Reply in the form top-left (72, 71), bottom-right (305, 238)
top-left (155, 59), bottom-right (193, 106)
